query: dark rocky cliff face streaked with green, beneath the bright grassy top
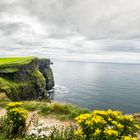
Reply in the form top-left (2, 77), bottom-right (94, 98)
top-left (0, 58), bottom-right (54, 101)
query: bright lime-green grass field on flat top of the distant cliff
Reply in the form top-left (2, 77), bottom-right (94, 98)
top-left (0, 57), bottom-right (34, 65)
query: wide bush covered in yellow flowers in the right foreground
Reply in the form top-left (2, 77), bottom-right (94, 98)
top-left (75, 110), bottom-right (139, 140)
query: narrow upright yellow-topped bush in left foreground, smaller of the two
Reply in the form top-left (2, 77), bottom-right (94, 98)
top-left (2, 102), bottom-right (27, 138)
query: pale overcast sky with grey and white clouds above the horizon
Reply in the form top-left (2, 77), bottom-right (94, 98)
top-left (0, 0), bottom-right (140, 63)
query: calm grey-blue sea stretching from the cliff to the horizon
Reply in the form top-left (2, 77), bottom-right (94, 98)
top-left (52, 62), bottom-right (140, 113)
